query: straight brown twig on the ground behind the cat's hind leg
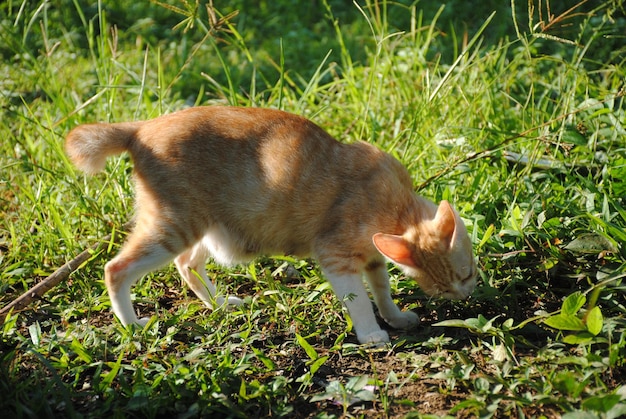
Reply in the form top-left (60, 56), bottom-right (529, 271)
top-left (0, 224), bottom-right (129, 323)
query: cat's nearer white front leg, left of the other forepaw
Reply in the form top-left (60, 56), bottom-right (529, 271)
top-left (324, 270), bottom-right (389, 344)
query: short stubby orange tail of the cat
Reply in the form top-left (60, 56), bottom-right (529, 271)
top-left (65, 122), bottom-right (143, 174)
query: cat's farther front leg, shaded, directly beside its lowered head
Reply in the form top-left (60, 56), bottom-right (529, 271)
top-left (365, 261), bottom-right (419, 329)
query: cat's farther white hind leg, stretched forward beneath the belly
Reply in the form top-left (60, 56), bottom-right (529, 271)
top-left (174, 241), bottom-right (243, 308)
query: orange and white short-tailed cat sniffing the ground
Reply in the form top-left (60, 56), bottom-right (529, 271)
top-left (65, 106), bottom-right (477, 344)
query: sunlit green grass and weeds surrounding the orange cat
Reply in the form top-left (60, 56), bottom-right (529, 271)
top-left (0, 0), bottom-right (626, 418)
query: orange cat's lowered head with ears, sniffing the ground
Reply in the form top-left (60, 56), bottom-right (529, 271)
top-left (373, 201), bottom-right (478, 299)
